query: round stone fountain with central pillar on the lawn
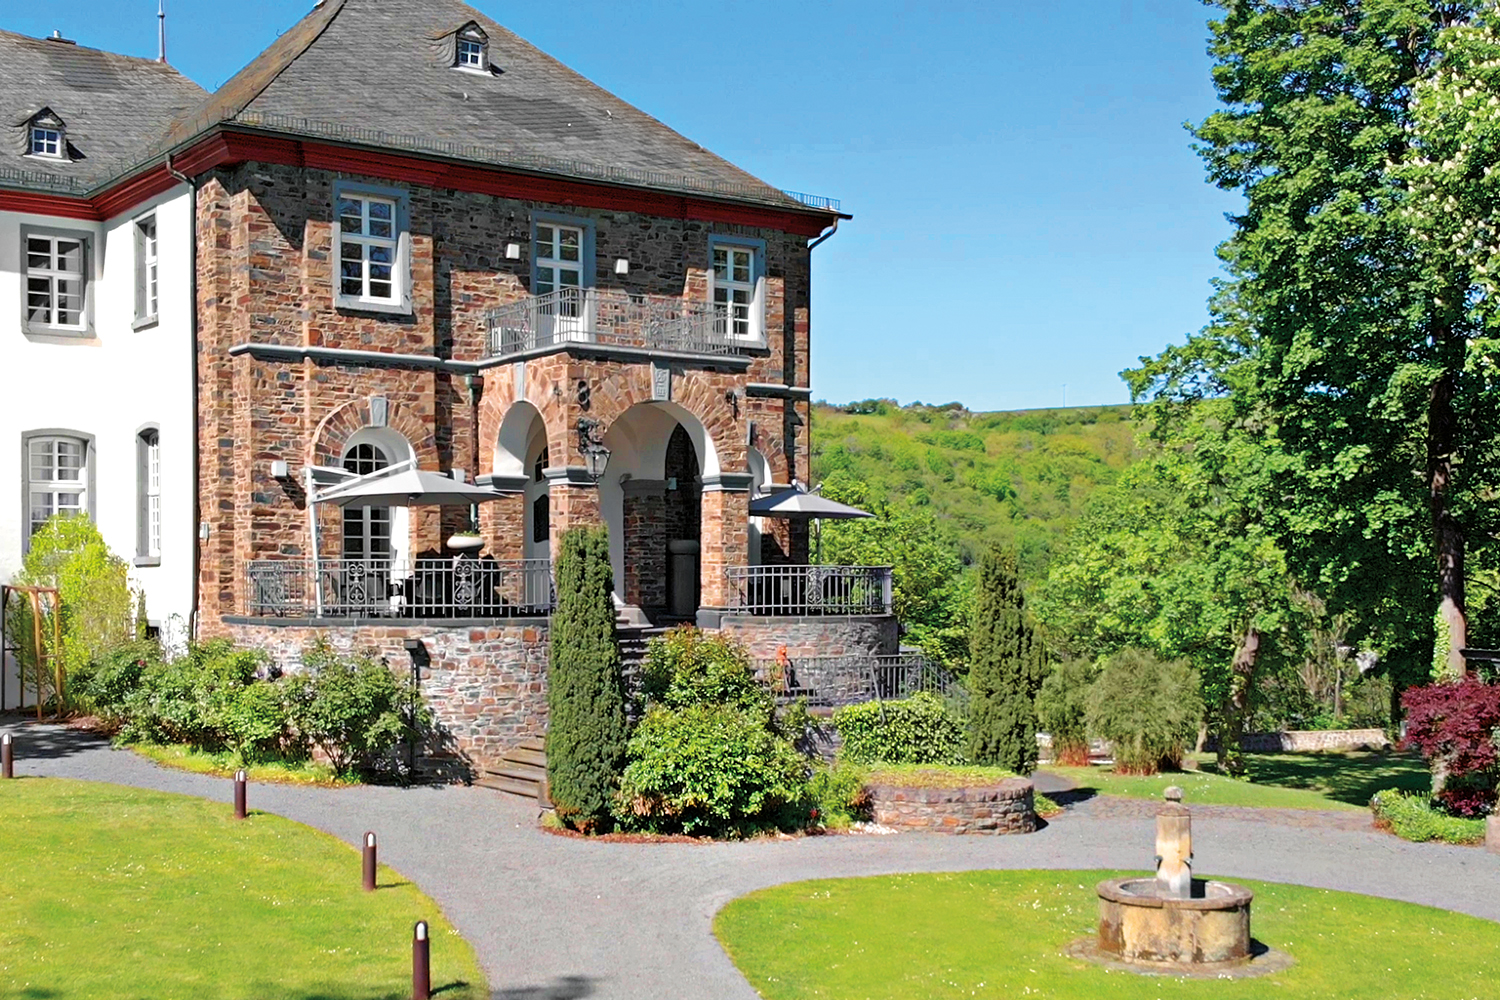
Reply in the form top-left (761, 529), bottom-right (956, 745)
top-left (1070, 787), bottom-right (1290, 975)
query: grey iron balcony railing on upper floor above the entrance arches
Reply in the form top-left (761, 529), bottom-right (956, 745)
top-left (488, 288), bottom-right (753, 358)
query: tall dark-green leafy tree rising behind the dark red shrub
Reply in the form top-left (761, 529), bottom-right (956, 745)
top-left (1128, 0), bottom-right (1500, 684)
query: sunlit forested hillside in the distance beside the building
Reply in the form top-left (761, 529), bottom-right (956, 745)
top-left (813, 399), bottom-right (1137, 582)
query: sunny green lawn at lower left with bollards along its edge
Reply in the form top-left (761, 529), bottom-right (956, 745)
top-left (0, 778), bottom-right (489, 1000)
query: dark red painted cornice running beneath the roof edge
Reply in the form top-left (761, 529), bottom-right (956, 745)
top-left (0, 130), bottom-right (836, 237)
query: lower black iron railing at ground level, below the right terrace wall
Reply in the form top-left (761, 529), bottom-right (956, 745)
top-left (755, 652), bottom-right (969, 715)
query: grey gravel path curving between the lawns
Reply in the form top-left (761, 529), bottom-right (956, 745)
top-left (0, 724), bottom-right (1500, 1000)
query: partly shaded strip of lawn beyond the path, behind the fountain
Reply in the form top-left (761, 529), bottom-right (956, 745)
top-left (1043, 751), bottom-right (1433, 810)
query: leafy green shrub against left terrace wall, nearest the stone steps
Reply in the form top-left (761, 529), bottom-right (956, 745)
top-left (291, 639), bottom-right (428, 777)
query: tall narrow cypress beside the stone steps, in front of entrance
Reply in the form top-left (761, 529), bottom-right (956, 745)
top-left (546, 526), bottom-right (626, 831)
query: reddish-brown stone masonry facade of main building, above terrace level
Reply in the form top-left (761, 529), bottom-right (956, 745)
top-left (198, 163), bottom-right (810, 621)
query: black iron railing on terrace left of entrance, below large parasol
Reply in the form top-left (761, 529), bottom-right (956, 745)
top-left (246, 556), bottom-right (554, 618)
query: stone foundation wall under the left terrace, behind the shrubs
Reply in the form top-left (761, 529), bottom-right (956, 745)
top-left (219, 619), bottom-right (548, 778)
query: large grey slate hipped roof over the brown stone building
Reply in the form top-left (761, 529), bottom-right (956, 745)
top-left (173, 0), bottom-right (806, 208)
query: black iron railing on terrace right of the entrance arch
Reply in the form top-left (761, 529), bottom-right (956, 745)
top-left (725, 565), bottom-right (891, 615)
